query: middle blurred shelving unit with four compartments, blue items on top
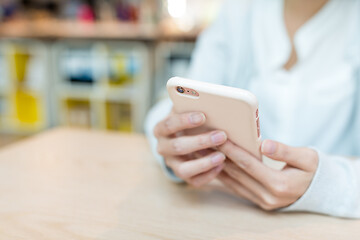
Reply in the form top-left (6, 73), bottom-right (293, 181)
top-left (53, 41), bottom-right (150, 132)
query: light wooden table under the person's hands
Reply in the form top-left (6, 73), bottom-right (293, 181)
top-left (0, 129), bottom-right (360, 240)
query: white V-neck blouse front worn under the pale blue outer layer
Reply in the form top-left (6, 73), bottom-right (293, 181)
top-left (248, 0), bottom-right (360, 155)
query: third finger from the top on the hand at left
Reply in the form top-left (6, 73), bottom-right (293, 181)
top-left (173, 152), bottom-right (225, 179)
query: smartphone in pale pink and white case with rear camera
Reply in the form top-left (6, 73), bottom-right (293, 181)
top-left (167, 77), bottom-right (262, 160)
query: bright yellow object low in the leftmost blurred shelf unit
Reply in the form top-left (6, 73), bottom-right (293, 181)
top-left (15, 90), bottom-right (42, 124)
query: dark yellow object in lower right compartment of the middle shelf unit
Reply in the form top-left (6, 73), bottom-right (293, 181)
top-left (106, 102), bottom-right (133, 132)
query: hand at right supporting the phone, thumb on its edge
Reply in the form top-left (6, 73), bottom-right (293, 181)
top-left (218, 140), bottom-right (318, 210)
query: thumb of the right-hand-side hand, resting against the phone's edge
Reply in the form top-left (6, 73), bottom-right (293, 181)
top-left (261, 140), bottom-right (318, 171)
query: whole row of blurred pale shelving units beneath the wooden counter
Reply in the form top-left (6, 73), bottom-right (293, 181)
top-left (0, 39), bottom-right (194, 134)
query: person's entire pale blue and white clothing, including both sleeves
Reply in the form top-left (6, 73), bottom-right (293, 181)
top-left (145, 0), bottom-right (360, 218)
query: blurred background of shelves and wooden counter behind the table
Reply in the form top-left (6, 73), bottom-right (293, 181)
top-left (0, 0), bottom-right (222, 146)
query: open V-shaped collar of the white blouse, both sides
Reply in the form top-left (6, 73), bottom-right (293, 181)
top-left (252, 0), bottom-right (356, 73)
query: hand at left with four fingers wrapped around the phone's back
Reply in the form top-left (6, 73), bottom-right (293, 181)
top-left (154, 112), bottom-right (227, 187)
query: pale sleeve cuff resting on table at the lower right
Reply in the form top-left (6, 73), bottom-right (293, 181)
top-left (280, 151), bottom-right (360, 218)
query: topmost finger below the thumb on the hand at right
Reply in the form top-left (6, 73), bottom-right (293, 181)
top-left (219, 141), bottom-right (279, 187)
